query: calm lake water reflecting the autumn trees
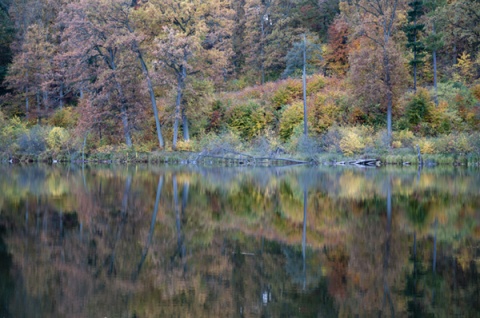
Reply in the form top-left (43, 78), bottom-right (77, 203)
top-left (0, 165), bottom-right (480, 317)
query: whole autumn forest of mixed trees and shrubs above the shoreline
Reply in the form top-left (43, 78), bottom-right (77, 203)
top-left (0, 0), bottom-right (480, 162)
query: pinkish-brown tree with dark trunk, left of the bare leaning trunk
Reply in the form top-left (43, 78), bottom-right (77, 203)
top-left (61, 0), bottom-right (140, 147)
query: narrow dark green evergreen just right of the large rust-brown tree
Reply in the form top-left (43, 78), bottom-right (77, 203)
top-left (405, 0), bottom-right (425, 92)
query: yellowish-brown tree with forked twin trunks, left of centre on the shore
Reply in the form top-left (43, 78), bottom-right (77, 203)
top-left (150, 0), bottom-right (233, 149)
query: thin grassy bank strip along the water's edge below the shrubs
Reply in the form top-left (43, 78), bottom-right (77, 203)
top-left (0, 149), bottom-right (480, 166)
